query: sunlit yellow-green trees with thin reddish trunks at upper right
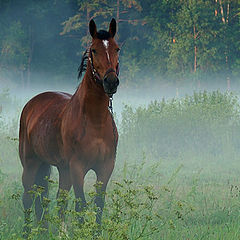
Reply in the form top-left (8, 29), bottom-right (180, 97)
top-left (144, 0), bottom-right (238, 84)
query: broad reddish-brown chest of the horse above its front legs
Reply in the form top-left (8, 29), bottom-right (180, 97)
top-left (63, 115), bottom-right (115, 165)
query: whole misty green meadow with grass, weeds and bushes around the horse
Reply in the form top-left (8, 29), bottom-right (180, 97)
top-left (0, 91), bottom-right (240, 240)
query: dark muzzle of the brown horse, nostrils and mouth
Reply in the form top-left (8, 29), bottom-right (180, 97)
top-left (103, 70), bottom-right (119, 97)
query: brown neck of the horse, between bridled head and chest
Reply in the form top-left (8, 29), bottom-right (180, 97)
top-left (72, 65), bottom-right (109, 124)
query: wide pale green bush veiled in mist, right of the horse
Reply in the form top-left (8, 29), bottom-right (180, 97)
top-left (120, 91), bottom-right (240, 159)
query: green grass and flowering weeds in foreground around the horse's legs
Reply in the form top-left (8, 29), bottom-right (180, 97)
top-left (0, 158), bottom-right (240, 240)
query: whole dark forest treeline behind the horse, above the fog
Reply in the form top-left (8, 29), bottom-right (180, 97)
top-left (0, 0), bottom-right (240, 87)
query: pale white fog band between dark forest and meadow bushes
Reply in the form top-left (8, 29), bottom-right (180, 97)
top-left (1, 73), bottom-right (240, 121)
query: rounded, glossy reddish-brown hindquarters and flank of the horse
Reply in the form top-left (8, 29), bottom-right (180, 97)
top-left (19, 92), bottom-right (71, 166)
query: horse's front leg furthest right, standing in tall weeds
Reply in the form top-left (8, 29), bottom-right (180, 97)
top-left (95, 160), bottom-right (114, 225)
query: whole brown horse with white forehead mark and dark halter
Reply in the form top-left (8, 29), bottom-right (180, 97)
top-left (19, 19), bottom-right (119, 234)
